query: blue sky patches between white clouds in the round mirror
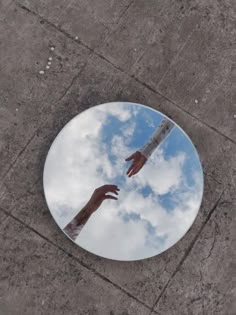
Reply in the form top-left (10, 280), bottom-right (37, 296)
top-left (101, 105), bottom-right (201, 215)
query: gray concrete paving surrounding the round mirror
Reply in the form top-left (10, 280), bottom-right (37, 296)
top-left (0, 0), bottom-right (236, 315)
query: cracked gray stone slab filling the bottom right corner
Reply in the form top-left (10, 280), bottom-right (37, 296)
top-left (152, 191), bottom-right (236, 315)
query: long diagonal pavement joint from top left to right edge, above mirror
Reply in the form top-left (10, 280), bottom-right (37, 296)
top-left (17, 2), bottom-right (236, 145)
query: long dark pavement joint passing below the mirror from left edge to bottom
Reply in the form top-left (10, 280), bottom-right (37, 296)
top-left (0, 207), bottom-right (157, 310)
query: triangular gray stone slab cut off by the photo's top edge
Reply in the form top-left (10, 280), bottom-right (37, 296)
top-left (18, 0), bottom-right (131, 48)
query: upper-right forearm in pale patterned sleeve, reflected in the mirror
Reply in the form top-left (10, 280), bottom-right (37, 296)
top-left (139, 119), bottom-right (174, 159)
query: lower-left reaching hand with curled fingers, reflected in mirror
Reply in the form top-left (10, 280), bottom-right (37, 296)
top-left (87, 185), bottom-right (120, 214)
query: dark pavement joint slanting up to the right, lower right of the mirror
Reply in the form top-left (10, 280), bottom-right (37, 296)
top-left (149, 189), bottom-right (225, 315)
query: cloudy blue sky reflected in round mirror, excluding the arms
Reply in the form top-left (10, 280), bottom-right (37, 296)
top-left (44, 103), bottom-right (203, 260)
